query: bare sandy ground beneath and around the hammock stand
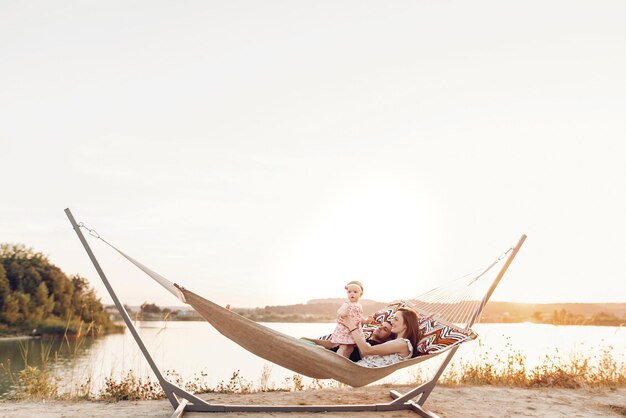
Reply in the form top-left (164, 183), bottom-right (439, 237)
top-left (0, 386), bottom-right (626, 418)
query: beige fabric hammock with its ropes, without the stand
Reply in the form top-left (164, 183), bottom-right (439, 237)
top-left (108, 251), bottom-right (498, 387)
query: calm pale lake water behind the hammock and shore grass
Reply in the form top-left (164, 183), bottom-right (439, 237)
top-left (0, 322), bottom-right (626, 398)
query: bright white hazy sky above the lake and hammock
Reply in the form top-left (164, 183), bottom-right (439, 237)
top-left (0, 0), bottom-right (626, 306)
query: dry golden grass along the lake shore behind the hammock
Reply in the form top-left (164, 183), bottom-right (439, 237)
top-left (0, 324), bottom-right (626, 401)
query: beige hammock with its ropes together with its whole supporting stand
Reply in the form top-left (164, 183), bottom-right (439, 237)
top-left (66, 209), bottom-right (526, 416)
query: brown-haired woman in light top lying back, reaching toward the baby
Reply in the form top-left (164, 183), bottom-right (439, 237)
top-left (339, 307), bottom-right (419, 367)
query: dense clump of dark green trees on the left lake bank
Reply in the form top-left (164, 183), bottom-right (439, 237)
top-left (0, 244), bottom-right (117, 334)
